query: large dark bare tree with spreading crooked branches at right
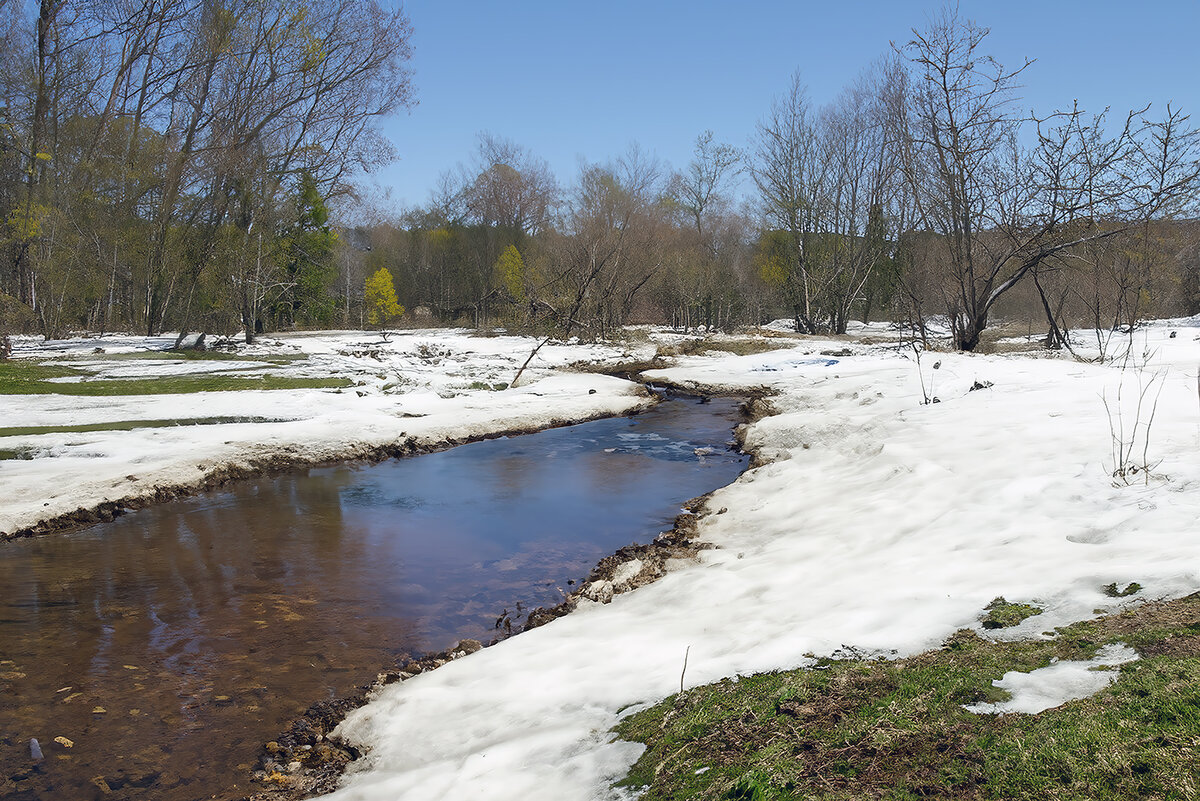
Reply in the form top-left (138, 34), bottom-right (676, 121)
top-left (900, 8), bottom-right (1200, 350)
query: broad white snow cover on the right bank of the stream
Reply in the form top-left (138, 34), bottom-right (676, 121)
top-left (319, 320), bottom-right (1200, 801)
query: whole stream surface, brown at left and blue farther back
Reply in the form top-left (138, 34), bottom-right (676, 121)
top-left (0, 398), bottom-right (745, 801)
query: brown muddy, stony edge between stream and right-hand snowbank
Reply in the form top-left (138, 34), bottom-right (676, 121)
top-left (238, 381), bottom-right (776, 801)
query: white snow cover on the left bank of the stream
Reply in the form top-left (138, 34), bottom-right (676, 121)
top-left (0, 330), bottom-right (654, 532)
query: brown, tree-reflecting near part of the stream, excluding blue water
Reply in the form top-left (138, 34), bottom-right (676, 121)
top-left (0, 476), bottom-right (407, 797)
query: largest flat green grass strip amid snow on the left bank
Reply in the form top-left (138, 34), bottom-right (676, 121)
top-left (0, 361), bottom-right (354, 396)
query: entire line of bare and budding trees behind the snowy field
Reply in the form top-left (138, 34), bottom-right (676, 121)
top-left (0, 0), bottom-right (1200, 355)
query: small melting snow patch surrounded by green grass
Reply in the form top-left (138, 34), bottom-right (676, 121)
top-left (962, 643), bottom-right (1138, 715)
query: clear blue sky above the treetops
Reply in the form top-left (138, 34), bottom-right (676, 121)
top-left (364, 0), bottom-right (1200, 206)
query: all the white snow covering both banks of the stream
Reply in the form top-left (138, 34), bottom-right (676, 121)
top-left (0, 320), bottom-right (1200, 801)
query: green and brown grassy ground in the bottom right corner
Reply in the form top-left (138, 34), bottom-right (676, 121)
top-left (617, 596), bottom-right (1200, 801)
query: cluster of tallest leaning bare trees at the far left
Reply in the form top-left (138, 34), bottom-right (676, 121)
top-left (0, 0), bottom-right (413, 336)
